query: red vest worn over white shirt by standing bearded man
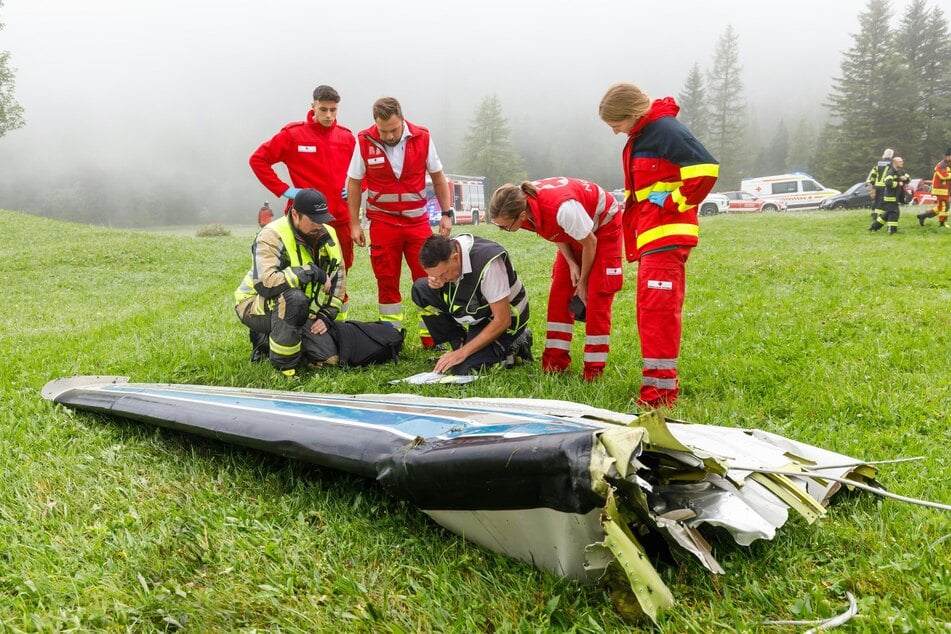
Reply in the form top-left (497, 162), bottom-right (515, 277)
top-left (357, 119), bottom-right (429, 222)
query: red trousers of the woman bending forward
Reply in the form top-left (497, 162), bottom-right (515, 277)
top-left (542, 218), bottom-right (624, 381)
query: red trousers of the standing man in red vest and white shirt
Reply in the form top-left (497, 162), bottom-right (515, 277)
top-left (369, 215), bottom-right (433, 336)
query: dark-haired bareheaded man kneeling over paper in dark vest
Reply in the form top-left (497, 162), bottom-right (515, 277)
top-left (413, 234), bottom-right (532, 374)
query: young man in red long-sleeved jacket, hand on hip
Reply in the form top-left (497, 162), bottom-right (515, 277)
top-left (249, 85), bottom-right (359, 278)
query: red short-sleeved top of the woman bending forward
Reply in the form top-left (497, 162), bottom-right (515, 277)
top-left (522, 176), bottom-right (617, 243)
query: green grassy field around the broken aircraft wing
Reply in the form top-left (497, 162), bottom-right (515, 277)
top-left (0, 206), bottom-right (951, 632)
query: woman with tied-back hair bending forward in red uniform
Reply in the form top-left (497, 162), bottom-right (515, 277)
top-left (489, 176), bottom-right (624, 381)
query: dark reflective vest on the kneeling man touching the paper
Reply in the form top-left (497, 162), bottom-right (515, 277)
top-left (441, 236), bottom-right (529, 332)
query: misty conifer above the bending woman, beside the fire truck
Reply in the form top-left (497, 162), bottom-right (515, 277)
top-left (461, 95), bottom-right (527, 194)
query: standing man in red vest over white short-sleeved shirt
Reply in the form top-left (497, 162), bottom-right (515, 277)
top-left (347, 97), bottom-right (452, 348)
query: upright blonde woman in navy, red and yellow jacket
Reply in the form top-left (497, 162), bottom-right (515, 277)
top-left (599, 83), bottom-right (720, 408)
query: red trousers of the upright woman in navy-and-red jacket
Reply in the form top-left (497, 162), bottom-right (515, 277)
top-left (637, 247), bottom-right (690, 407)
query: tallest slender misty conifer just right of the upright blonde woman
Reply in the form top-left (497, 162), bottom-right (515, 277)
top-left (705, 25), bottom-right (746, 189)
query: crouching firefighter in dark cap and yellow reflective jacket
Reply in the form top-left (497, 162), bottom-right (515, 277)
top-left (234, 189), bottom-right (346, 376)
